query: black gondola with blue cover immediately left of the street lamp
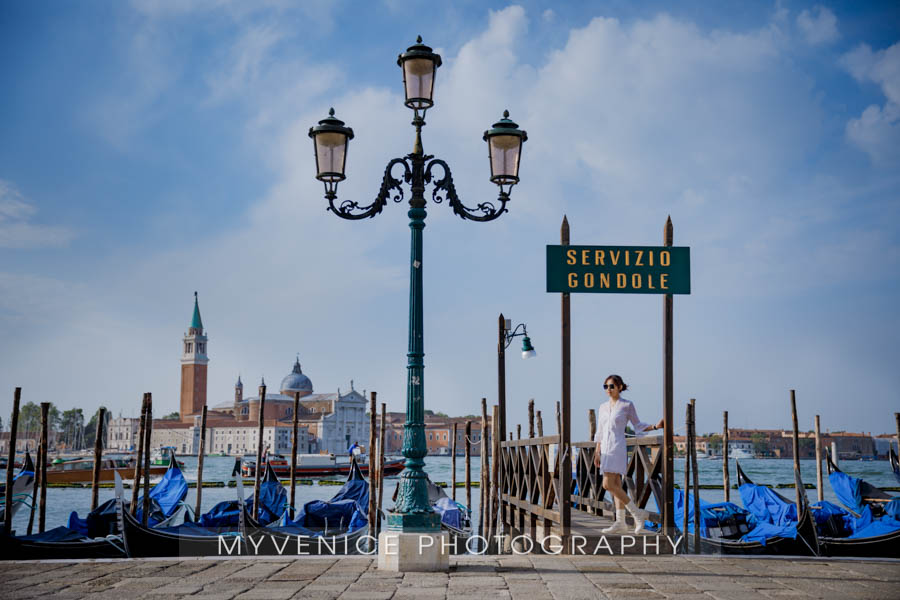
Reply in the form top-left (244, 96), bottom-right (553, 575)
top-left (244, 459), bottom-right (369, 556)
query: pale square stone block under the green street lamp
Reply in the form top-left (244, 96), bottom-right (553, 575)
top-left (378, 530), bottom-right (450, 573)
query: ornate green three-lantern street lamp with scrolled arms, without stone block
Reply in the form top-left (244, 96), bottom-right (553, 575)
top-left (309, 36), bottom-right (527, 532)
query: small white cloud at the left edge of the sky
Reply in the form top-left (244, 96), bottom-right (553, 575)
top-left (0, 179), bottom-right (75, 248)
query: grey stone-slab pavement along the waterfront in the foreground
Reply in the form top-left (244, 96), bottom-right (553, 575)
top-left (0, 555), bottom-right (900, 600)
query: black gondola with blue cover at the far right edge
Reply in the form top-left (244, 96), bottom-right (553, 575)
top-left (813, 449), bottom-right (900, 558)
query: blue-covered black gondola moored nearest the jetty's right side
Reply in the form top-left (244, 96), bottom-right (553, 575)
top-left (696, 461), bottom-right (819, 556)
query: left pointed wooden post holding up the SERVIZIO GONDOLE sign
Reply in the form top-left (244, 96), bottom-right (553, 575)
top-left (558, 216), bottom-right (572, 549)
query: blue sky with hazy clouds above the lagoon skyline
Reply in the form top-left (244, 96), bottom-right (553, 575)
top-left (0, 0), bottom-right (900, 439)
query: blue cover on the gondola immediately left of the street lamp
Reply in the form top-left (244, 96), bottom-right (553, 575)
top-left (279, 479), bottom-right (369, 536)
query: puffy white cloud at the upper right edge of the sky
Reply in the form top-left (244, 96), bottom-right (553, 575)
top-left (841, 43), bottom-right (900, 165)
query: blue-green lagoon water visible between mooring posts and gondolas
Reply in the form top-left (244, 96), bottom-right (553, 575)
top-left (0, 456), bottom-right (898, 532)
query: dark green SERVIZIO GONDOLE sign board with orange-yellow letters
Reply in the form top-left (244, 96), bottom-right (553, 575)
top-left (547, 246), bottom-right (691, 294)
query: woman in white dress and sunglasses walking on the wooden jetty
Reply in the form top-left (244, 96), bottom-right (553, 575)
top-left (594, 375), bottom-right (663, 533)
